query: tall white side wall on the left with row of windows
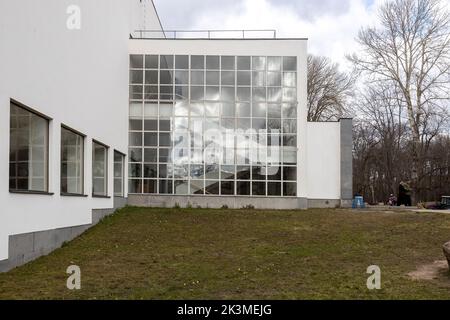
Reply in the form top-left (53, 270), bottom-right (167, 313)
top-left (0, 0), bottom-right (159, 260)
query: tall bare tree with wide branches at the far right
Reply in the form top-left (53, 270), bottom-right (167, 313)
top-left (349, 0), bottom-right (450, 199)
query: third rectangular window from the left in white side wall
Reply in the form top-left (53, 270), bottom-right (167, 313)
top-left (92, 141), bottom-right (108, 197)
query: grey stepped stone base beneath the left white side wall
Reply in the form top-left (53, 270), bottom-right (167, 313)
top-left (0, 198), bottom-right (127, 272)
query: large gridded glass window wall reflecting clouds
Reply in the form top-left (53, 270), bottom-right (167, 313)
top-left (129, 55), bottom-right (297, 197)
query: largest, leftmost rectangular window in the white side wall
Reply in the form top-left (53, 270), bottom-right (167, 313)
top-left (9, 103), bottom-right (49, 192)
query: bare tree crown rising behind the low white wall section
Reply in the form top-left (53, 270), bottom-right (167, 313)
top-left (308, 55), bottom-right (353, 122)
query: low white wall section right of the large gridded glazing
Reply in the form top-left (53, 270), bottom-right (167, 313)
top-left (306, 122), bottom-right (341, 200)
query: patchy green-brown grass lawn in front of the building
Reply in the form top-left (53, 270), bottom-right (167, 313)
top-left (0, 208), bottom-right (450, 299)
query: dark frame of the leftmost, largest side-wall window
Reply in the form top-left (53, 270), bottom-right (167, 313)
top-left (8, 98), bottom-right (54, 196)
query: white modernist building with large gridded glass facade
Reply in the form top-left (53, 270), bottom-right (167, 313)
top-left (0, 0), bottom-right (352, 271)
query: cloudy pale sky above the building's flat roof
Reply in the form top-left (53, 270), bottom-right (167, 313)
top-left (154, 0), bottom-right (385, 69)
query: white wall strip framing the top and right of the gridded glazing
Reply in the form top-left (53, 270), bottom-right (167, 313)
top-left (130, 39), bottom-right (307, 198)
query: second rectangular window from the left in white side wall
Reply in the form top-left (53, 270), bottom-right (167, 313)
top-left (61, 127), bottom-right (84, 195)
